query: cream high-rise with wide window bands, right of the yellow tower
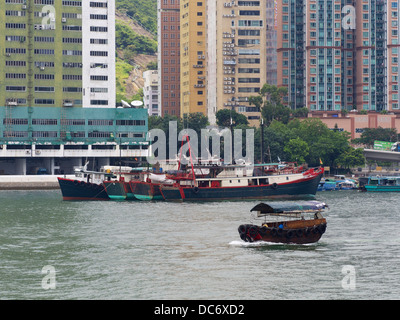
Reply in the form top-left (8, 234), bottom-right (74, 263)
top-left (207, 0), bottom-right (267, 124)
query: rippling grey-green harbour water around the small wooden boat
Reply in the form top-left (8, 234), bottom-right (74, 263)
top-left (0, 190), bottom-right (400, 300)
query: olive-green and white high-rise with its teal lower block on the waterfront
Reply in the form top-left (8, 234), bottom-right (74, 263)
top-left (0, 0), bottom-right (148, 175)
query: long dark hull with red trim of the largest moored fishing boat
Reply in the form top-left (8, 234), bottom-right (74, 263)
top-left (161, 170), bottom-right (323, 201)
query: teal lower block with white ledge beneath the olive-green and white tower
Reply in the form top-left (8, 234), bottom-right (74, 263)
top-left (0, 106), bottom-right (148, 175)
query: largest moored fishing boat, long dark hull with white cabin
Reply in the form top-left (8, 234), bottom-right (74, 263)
top-left (160, 165), bottom-right (324, 201)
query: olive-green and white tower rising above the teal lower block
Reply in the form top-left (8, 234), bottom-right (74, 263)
top-left (0, 0), bottom-right (115, 108)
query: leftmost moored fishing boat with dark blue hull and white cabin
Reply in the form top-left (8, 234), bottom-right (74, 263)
top-left (57, 163), bottom-right (115, 200)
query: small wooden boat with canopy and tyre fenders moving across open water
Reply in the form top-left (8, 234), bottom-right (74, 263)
top-left (238, 201), bottom-right (327, 244)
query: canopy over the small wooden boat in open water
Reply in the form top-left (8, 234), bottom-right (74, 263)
top-left (250, 201), bottom-right (328, 214)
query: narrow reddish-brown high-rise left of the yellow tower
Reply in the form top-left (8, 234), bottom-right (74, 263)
top-left (157, 0), bottom-right (181, 116)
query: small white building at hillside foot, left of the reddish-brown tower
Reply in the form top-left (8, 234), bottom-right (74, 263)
top-left (143, 70), bottom-right (161, 116)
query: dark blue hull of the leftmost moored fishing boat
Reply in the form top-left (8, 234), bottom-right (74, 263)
top-left (58, 177), bottom-right (110, 200)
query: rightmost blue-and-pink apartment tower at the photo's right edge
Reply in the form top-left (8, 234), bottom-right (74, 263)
top-left (355, 0), bottom-right (386, 110)
